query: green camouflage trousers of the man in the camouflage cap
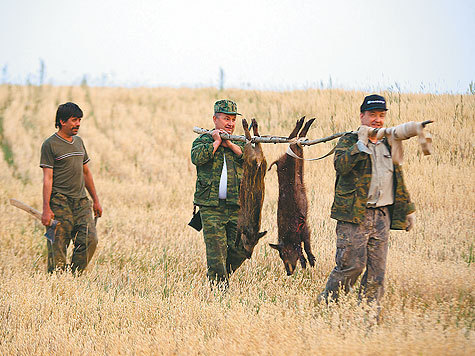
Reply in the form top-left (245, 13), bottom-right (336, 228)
top-left (200, 200), bottom-right (246, 283)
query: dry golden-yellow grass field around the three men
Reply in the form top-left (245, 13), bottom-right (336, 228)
top-left (0, 85), bottom-right (475, 355)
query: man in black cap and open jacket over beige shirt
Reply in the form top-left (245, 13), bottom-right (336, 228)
top-left (319, 95), bottom-right (415, 305)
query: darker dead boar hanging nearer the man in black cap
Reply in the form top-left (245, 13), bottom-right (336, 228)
top-left (269, 117), bottom-right (315, 276)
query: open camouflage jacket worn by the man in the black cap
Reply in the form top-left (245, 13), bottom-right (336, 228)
top-left (331, 133), bottom-right (416, 230)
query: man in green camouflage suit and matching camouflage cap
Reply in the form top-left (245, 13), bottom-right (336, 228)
top-left (191, 100), bottom-right (246, 286)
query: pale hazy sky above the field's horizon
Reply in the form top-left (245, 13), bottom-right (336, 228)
top-left (0, 0), bottom-right (475, 93)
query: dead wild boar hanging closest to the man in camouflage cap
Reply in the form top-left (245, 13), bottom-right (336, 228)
top-left (236, 119), bottom-right (267, 258)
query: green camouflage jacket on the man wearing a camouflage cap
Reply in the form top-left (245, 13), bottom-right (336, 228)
top-left (191, 134), bottom-right (245, 206)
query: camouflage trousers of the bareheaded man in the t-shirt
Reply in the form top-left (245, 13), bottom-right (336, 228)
top-left (47, 193), bottom-right (97, 273)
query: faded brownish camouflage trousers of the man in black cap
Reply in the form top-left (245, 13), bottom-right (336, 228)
top-left (322, 207), bottom-right (391, 303)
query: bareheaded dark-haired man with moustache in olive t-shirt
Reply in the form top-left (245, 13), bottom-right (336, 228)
top-left (40, 103), bottom-right (102, 273)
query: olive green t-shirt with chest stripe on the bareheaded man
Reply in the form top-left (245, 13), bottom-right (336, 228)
top-left (40, 133), bottom-right (89, 199)
